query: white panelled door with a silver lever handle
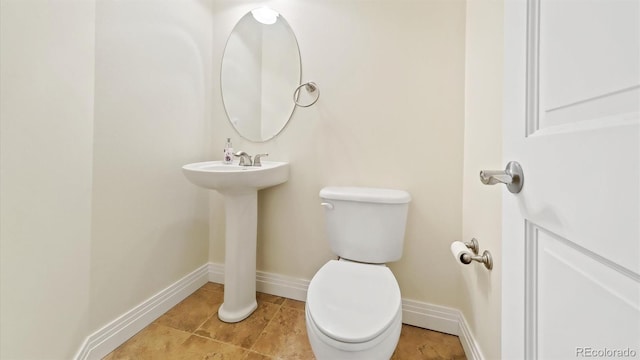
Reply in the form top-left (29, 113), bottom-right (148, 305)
top-left (501, 0), bottom-right (640, 360)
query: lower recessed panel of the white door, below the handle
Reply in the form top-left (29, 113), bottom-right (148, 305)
top-left (525, 223), bottom-right (640, 359)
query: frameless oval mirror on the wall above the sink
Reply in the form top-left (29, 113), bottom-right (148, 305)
top-left (220, 7), bottom-right (300, 142)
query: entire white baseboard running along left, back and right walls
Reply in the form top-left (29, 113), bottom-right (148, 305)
top-left (74, 262), bottom-right (484, 360)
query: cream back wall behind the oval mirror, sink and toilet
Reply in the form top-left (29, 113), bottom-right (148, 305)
top-left (209, 0), bottom-right (465, 308)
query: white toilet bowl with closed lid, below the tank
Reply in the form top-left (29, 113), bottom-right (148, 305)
top-left (305, 260), bottom-right (402, 360)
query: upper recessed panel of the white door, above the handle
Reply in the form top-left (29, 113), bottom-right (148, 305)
top-left (539, 0), bottom-right (640, 128)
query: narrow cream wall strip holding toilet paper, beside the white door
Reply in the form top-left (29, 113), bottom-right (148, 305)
top-left (460, 0), bottom-right (506, 359)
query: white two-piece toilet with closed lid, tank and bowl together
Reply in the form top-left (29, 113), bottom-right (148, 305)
top-left (305, 187), bottom-right (411, 360)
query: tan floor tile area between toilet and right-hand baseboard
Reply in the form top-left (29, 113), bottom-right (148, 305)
top-left (391, 324), bottom-right (466, 360)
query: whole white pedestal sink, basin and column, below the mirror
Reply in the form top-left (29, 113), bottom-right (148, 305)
top-left (182, 161), bottom-right (289, 322)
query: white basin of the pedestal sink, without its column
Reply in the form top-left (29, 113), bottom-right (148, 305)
top-left (182, 161), bottom-right (289, 194)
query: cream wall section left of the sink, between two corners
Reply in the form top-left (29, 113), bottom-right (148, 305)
top-left (90, 0), bottom-right (213, 330)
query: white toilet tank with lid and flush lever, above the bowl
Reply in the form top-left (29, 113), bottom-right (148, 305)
top-left (320, 187), bottom-right (411, 264)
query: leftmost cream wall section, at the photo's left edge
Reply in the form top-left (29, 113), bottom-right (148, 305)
top-left (0, 0), bottom-right (95, 359)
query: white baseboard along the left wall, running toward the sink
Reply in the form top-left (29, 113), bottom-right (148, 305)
top-left (74, 264), bottom-right (209, 360)
